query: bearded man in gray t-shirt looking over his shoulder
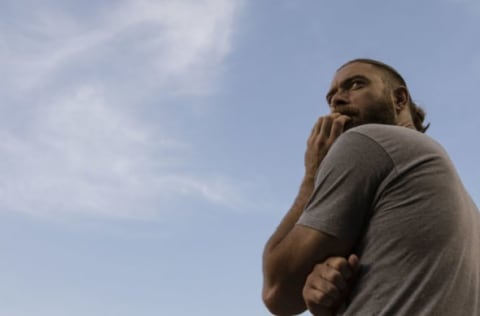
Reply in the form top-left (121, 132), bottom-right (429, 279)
top-left (262, 59), bottom-right (480, 315)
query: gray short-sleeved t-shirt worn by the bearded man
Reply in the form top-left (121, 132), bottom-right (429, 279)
top-left (298, 124), bottom-right (480, 316)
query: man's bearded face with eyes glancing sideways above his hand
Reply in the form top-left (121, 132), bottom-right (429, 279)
top-left (327, 62), bottom-right (396, 129)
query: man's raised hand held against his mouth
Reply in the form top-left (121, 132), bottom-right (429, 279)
top-left (305, 113), bottom-right (351, 178)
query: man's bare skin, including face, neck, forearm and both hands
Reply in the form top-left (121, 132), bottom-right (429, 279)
top-left (262, 62), bottom-right (414, 315)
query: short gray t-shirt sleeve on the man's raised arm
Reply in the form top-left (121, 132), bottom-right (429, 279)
top-left (297, 131), bottom-right (394, 245)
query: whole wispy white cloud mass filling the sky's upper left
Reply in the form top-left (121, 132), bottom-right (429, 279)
top-left (0, 0), bottom-right (246, 218)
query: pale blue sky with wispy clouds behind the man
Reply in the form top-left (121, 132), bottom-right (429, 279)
top-left (0, 0), bottom-right (480, 316)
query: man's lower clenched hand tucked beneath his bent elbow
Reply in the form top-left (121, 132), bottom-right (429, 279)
top-left (303, 255), bottom-right (359, 316)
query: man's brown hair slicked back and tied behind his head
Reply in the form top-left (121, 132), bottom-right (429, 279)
top-left (338, 58), bottom-right (430, 133)
